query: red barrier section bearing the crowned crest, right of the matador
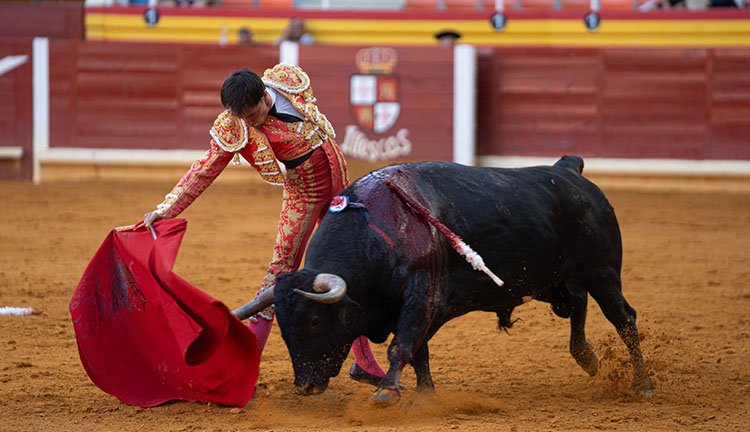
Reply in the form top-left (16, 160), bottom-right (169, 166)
top-left (299, 46), bottom-right (453, 172)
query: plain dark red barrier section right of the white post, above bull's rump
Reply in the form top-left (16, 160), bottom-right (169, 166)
top-left (478, 48), bottom-right (750, 160)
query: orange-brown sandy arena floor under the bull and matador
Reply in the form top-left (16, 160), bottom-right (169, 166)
top-left (0, 166), bottom-right (750, 432)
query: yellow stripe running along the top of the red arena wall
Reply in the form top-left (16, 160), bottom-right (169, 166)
top-left (86, 13), bottom-right (750, 47)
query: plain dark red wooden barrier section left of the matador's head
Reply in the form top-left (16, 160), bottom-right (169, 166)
top-left (50, 41), bottom-right (278, 150)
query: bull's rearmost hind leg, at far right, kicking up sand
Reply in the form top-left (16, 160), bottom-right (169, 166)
top-left (583, 268), bottom-right (654, 396)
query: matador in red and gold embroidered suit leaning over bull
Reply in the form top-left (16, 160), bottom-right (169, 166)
top-left (144, 64), bottom-right (384, 385)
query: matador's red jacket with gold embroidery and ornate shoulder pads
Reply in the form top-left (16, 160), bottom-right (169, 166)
top-left (156, 64), bottom-right (346, 218)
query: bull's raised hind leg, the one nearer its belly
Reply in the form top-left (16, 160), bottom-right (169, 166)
top-left (565, 282), bottom-right (599, 376)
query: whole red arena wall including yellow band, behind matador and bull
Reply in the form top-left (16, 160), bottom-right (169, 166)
top-left (0, 5), bottom-right (750, 176)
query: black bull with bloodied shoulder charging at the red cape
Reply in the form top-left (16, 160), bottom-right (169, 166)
top-left (235, 156), bottom-right (653, 401)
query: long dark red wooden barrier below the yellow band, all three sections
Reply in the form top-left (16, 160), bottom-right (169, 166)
top-left (7, 40), bottom-right (750, 179)
